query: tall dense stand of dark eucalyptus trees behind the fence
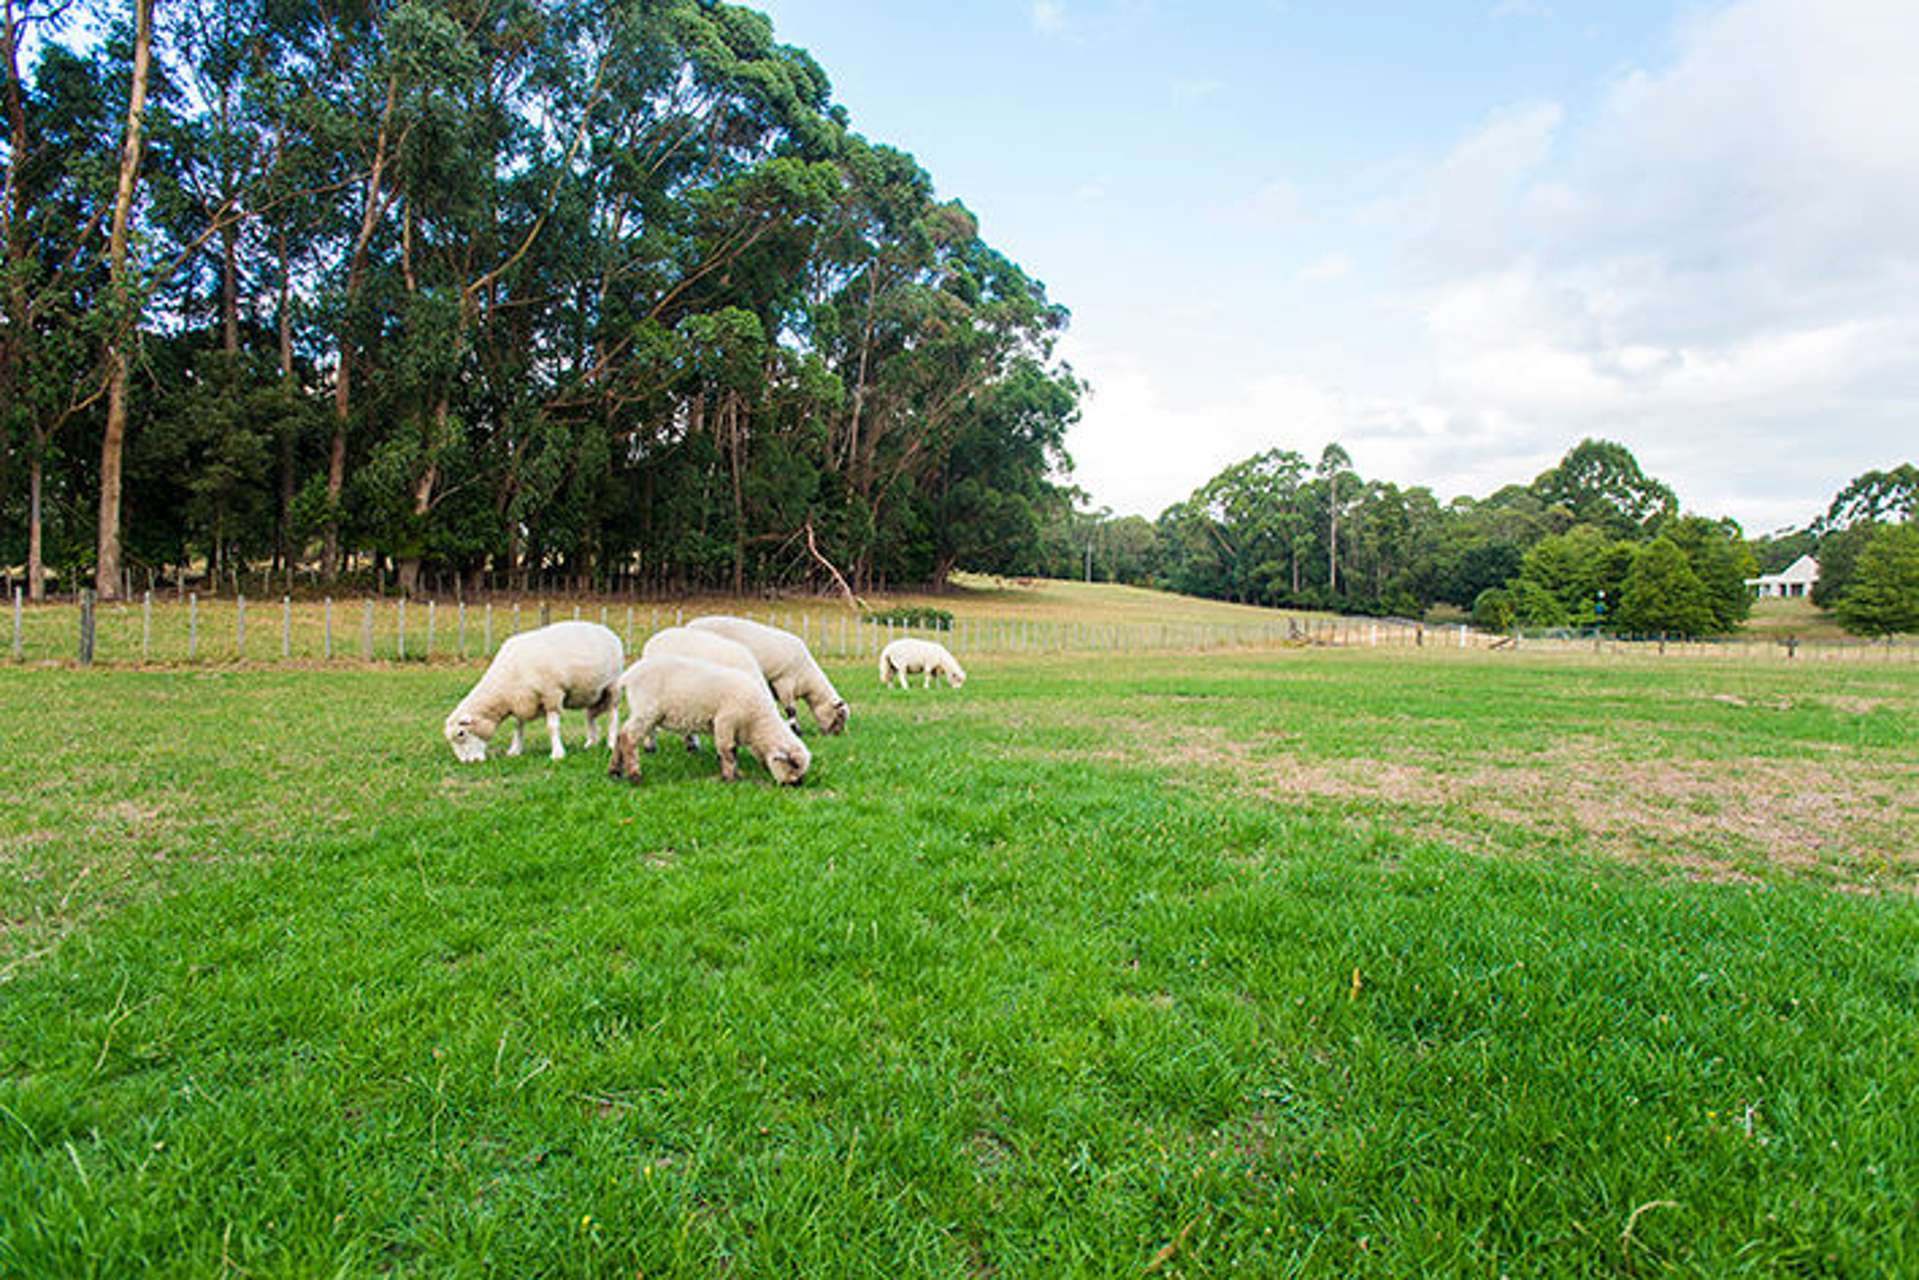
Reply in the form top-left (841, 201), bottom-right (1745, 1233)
top-left (0, 0), bottom-right (1080, 595)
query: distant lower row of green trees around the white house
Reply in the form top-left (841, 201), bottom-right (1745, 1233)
top-left (1044, 439), bottom-right (1919, 635)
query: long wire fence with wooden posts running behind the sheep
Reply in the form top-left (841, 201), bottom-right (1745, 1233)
top-left (10, 591), bottom-right (1919, 666)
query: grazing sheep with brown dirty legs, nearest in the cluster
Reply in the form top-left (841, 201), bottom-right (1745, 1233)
top-left (606, 654), bottom-right (812, 787)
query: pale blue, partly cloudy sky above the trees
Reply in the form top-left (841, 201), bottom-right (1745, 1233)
top-left (748, 0), bottom-right (1919, 535)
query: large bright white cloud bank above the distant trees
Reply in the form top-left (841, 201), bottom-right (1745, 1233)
top-left (1075, 0), bottom-right (1919, 532)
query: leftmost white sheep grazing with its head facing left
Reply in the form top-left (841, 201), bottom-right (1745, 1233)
top-left (445, 622), bottom-right (626, 764)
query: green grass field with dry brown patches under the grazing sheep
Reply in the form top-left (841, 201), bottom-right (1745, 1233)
top-left (0, 649), bottom-right (1919, 1276)
